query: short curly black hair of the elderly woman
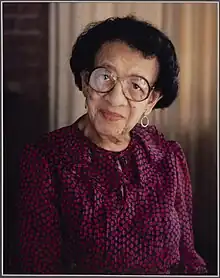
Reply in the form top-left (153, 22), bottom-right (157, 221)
top-left (70, 15), bottom-right (179, 108)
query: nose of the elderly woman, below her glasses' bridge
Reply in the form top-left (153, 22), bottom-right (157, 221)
top-left (106, 81), bottom-right (127, 106)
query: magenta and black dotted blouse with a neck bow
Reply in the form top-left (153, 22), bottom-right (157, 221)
top-left (19, 121), bottom-right (206, 274)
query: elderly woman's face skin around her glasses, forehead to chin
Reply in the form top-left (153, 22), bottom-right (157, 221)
top-left (82, 42), bottom-right (160, 137)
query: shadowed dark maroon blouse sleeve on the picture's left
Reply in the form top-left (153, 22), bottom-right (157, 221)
top-left (19, 146), bottom-right (62, 274)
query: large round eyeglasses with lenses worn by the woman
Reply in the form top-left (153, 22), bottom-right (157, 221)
top-left (87, 67), bottom-right (155, 102)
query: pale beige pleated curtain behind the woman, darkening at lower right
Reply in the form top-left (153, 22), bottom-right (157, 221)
top-left (49, 2), bottom-right (218, 273)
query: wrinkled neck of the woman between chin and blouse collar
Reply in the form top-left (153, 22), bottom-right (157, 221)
top-left (78, 115), bottom-right (131, 152)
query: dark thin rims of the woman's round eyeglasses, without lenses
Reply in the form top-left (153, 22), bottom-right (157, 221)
top-left (83, 66), bottom-right (156, 102)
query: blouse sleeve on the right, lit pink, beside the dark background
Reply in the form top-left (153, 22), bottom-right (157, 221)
top-left (175, 144), bottom-right (207, 274)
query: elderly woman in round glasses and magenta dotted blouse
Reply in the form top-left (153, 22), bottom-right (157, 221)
top-left (20, 16), bottom-right (206, 274)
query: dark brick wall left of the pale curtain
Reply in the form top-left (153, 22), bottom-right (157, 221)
top-left (3, 3), bottom-right (48, 273)
